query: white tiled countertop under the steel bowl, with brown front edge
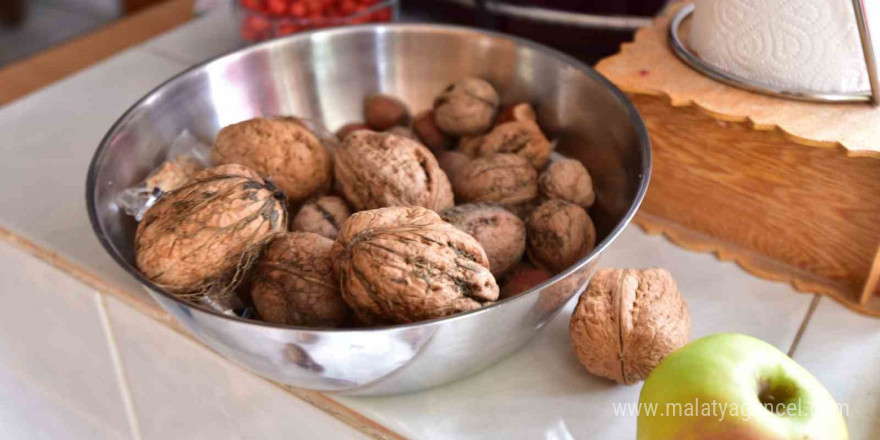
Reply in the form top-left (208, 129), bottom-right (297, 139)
top-left (0, 4), bottom-right (880, 439)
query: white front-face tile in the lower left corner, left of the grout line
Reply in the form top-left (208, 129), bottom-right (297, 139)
top-left (0, 242), bottom-right (131, 439)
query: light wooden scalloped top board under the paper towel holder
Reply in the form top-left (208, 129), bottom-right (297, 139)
top-left (596, 6), bottom-right (880, 158)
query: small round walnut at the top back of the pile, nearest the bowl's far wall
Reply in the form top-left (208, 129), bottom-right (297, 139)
top-left (434, 78), bottom-right (499, 136)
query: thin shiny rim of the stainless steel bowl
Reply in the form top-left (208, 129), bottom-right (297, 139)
top-left (86, 23), bottom-right (652, 333)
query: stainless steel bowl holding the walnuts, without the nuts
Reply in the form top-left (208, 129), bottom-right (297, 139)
top-left (87, 24), bottom-right (651, 395)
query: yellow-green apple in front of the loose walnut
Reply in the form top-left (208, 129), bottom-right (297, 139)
top-left (636, 333), bottom-right (849, 440)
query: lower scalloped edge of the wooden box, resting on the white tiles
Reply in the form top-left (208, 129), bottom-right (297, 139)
top-left (634, 212), bottom-right (880, 317)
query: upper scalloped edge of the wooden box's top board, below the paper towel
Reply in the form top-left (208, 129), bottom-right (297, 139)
top-left (595, 2), bottom-right (880, 159)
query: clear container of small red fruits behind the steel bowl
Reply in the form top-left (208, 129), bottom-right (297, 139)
top-left (234, 0), bottom-right (399, 42)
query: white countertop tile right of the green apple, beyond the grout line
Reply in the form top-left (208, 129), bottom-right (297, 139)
top-left (794, 298), bottom-right (880, 439)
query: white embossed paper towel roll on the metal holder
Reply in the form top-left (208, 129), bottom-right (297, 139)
top-left (690, 0), bottom-right (877, 93)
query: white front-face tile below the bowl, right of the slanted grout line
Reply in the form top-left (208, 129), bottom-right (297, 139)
top-left (107, 298), bottom-right (365, 440)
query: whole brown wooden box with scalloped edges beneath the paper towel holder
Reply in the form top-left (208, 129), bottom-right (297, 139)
top-left (597, 1), bottom-right (880, 315)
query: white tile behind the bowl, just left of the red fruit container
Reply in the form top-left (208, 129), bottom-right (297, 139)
top-left (141, 1), bottom-right (245, 64)
